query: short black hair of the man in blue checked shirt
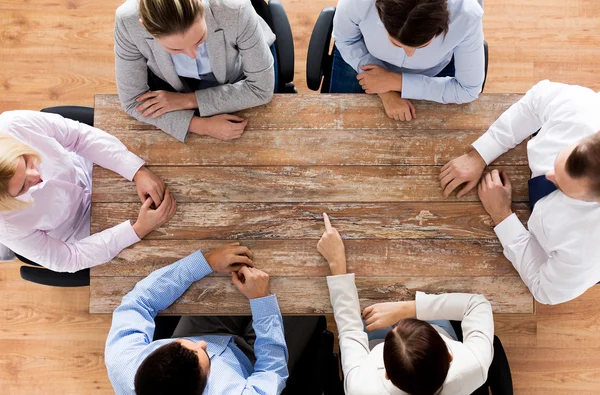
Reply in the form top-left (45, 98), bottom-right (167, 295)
top-left (134, 341), bottom-right (208, 395)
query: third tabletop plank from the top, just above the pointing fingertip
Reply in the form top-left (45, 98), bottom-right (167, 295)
top-left (92, 166), bottom-right (531, 203)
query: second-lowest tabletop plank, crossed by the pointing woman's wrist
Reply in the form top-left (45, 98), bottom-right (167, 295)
top-left (91, 239), bottom-right (518, 277)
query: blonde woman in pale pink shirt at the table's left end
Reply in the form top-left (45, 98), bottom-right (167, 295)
top-left (0, 111), bottom-right (176, 272)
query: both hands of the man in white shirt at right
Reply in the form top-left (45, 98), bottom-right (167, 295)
top-left (439, 149), bottom-right (512, 225)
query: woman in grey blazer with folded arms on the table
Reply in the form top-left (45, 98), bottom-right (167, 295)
top-left (115, 0), bottom-right (275, 141)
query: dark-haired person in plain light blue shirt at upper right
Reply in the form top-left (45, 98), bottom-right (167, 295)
top-left (330, 0), bottom-right (485, 121)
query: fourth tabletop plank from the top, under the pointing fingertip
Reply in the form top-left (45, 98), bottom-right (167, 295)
top-left (91, 202), bottom-right (529, 240)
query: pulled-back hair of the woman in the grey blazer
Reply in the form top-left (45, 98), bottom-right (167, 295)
top-left (140, 0), bottom-right (204, 37)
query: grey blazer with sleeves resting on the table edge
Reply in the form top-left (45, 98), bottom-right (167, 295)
top-left (115, 0), bottom-right (275, 141)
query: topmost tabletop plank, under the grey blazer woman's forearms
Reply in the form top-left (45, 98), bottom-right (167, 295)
top-left (94, 93), bottom-right (522, 132)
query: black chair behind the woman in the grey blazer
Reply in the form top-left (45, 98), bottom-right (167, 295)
top-left (251, 0), bottom-right (298, 93)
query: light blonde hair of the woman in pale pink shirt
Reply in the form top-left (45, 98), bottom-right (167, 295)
top-left (0, 135), bottom-right (42, 212)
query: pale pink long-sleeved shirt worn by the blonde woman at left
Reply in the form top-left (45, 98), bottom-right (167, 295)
top-left (0, 111), bottom-right (144, 272)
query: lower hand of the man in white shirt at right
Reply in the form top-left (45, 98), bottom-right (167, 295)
top-left (477, 170), bottom-right (512, 225)
